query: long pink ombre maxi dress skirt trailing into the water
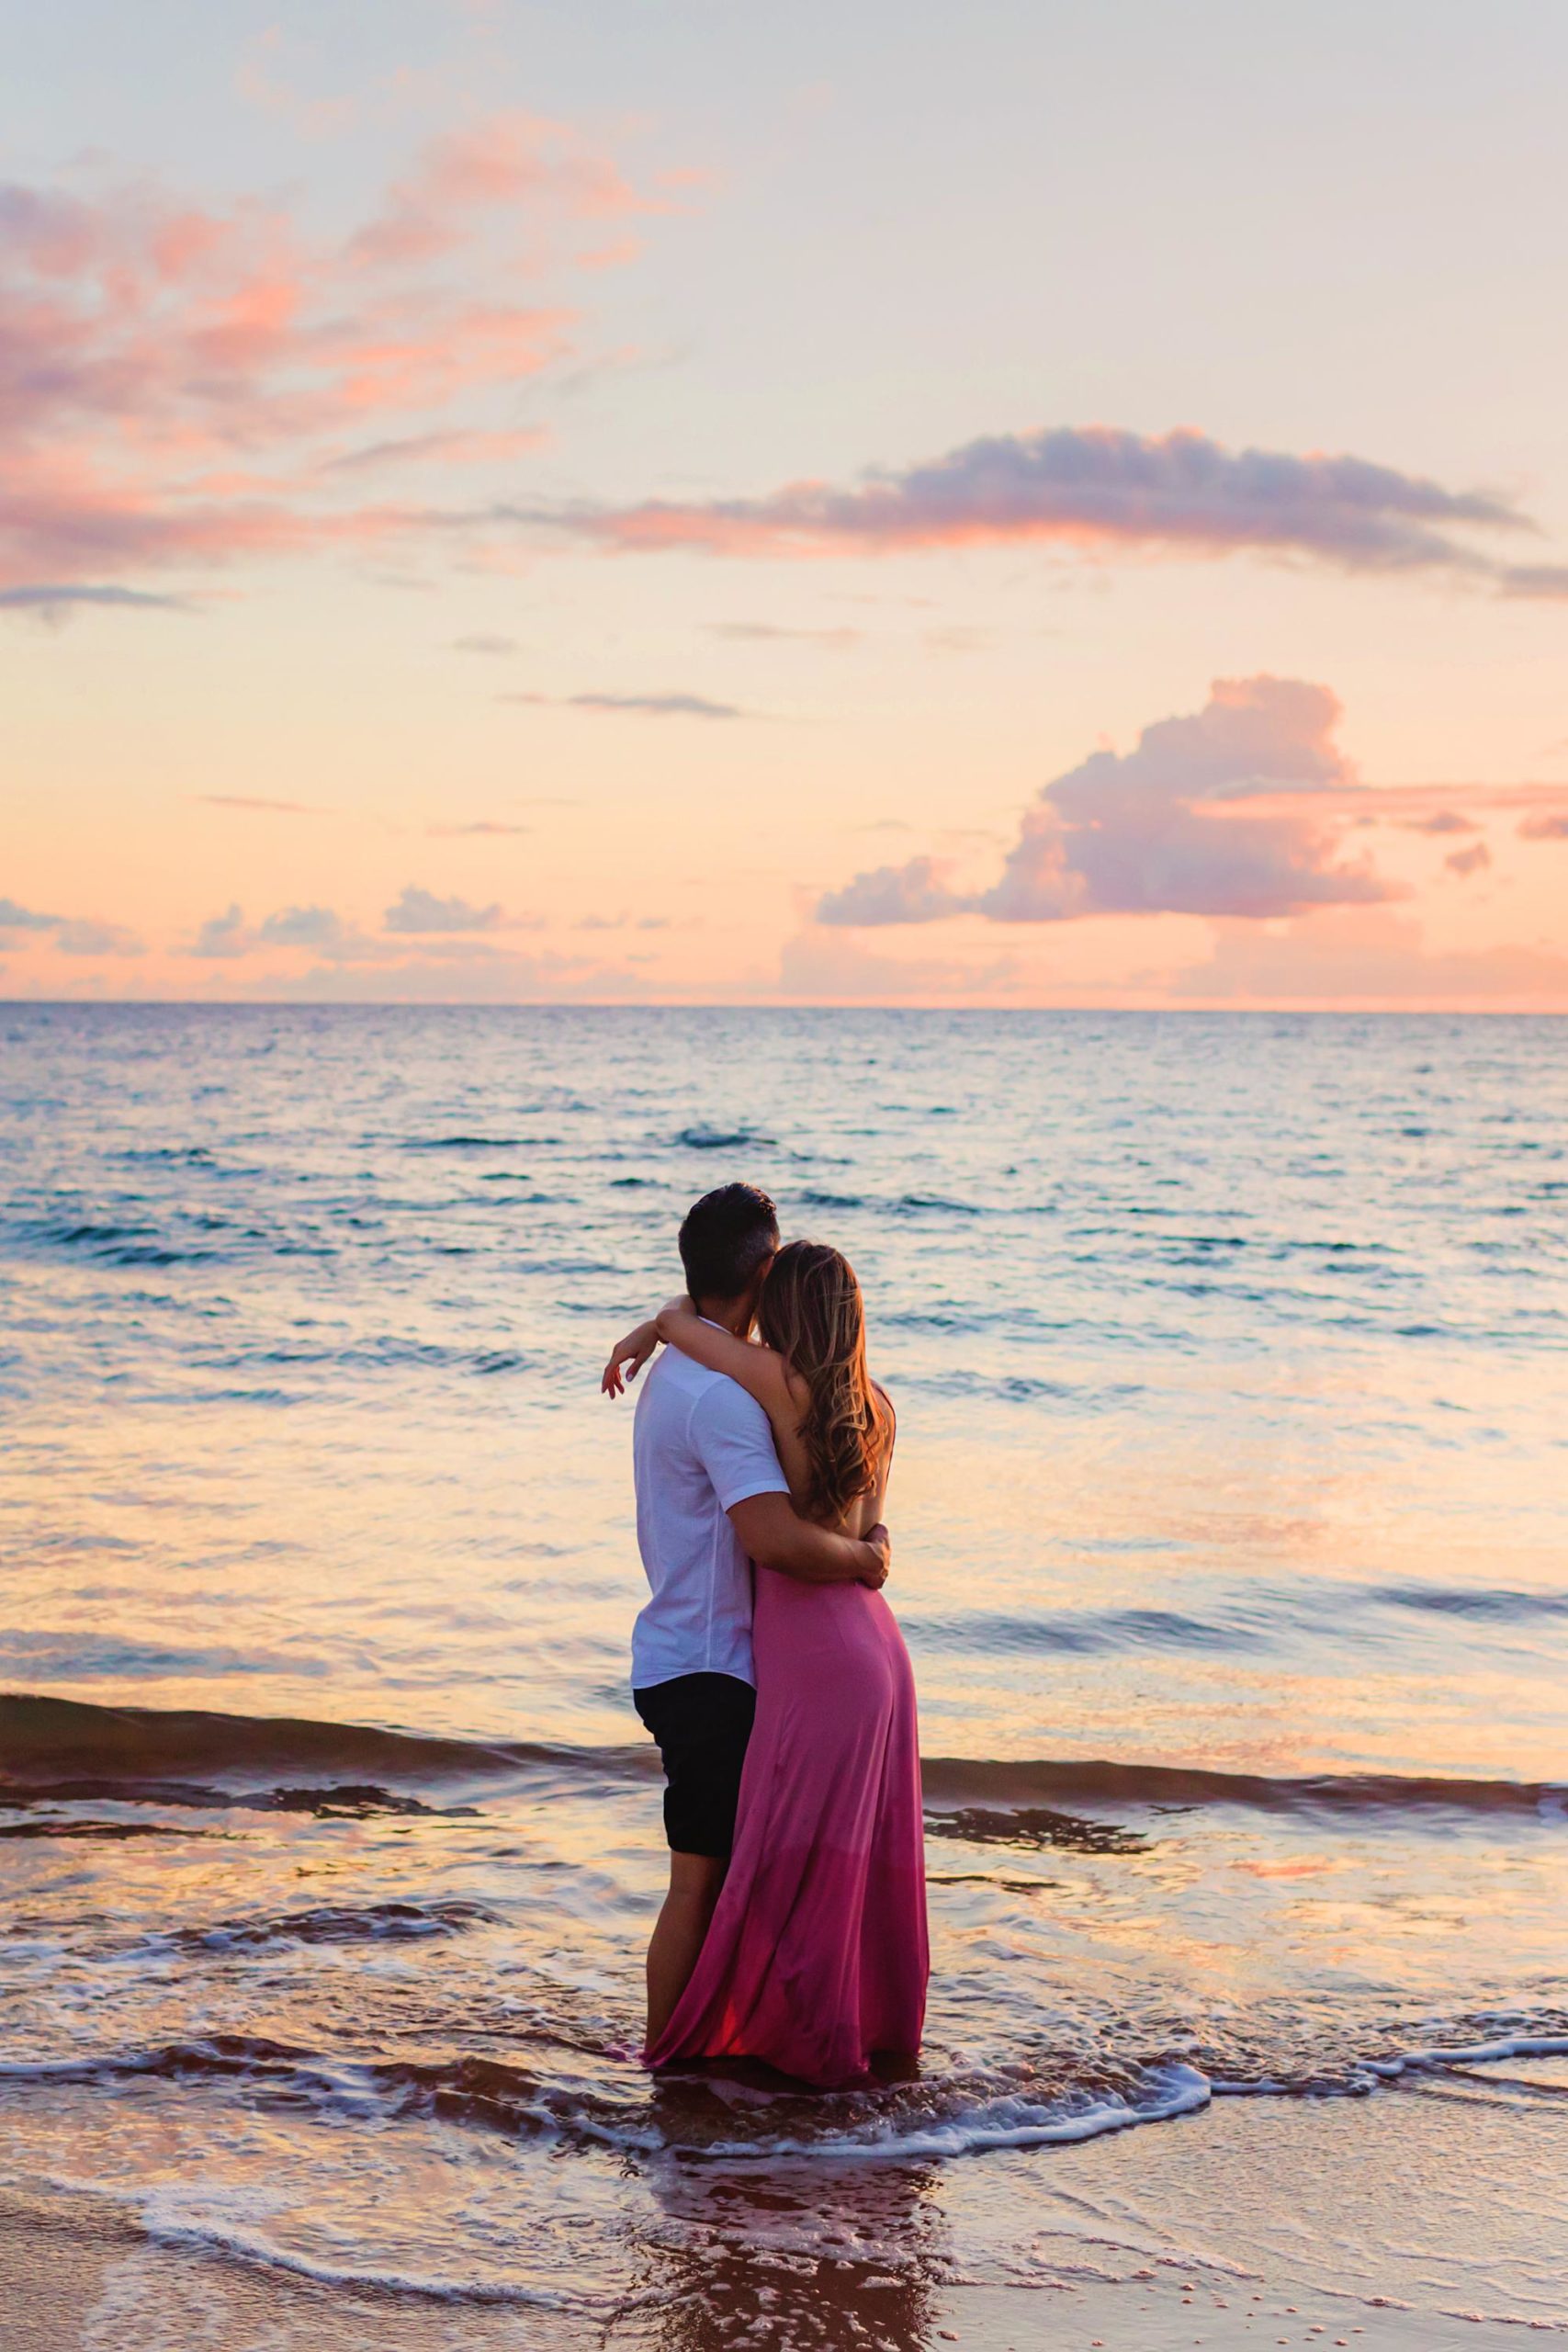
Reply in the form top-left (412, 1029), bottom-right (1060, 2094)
top-left (644, 1569), bottom-right (929, 2088)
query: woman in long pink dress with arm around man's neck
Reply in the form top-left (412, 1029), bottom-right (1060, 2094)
top-left (604, 1242), bottom-right (929, 2088)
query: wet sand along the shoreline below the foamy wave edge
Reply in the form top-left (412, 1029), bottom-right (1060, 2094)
top-left (0, 2079), bottom-right (1568, 2352)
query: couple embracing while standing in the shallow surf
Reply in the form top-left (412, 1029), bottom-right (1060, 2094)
top-left (604, 1183), bottom-right (929, 2088)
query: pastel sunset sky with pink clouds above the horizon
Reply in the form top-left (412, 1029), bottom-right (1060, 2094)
top-left (0, 0), bottom-right (1568, 1012)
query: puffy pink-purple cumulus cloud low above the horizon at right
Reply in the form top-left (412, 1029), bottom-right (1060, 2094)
top-left (818, 677), bottom-right (1396, 927)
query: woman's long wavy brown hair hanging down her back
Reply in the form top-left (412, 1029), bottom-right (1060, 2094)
top-left (757, 1242), bottom-right (894, 1520)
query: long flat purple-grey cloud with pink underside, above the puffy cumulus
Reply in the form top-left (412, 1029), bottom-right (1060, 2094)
top-left (529, 425), bottom-right (1551, 578)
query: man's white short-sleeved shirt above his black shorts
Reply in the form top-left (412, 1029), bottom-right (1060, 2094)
top-left (632, 1348), bottom-right (790, 1691)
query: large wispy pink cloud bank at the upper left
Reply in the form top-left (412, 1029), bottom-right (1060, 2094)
top-left (0, 115), bottom-right (647, 588)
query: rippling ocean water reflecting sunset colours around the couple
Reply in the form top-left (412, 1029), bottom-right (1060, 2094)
top-left (0, 1004), bottom-right (1568, 2352)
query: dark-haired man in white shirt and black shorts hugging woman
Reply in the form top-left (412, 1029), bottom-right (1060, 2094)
top-left (632, 1183), bottom-right (888, 2044)
